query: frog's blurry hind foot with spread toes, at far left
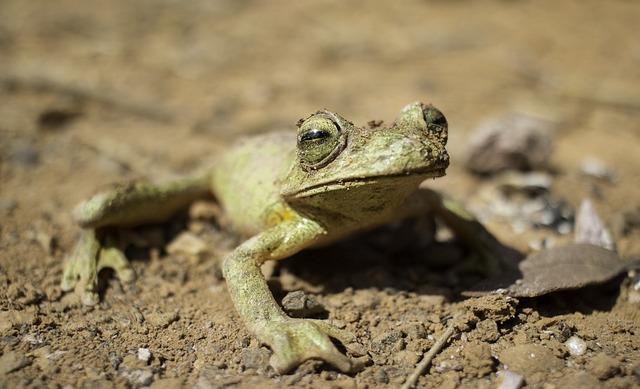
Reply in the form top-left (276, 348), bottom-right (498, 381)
top-left (60, 230), bottom-right (135, 305)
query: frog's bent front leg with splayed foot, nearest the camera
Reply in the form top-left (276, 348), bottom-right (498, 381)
top-left (223, 218), bottom-right (360, 373)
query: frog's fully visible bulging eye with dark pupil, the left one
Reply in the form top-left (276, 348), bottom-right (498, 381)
top-left (298, 113), bottom-right (345, 169)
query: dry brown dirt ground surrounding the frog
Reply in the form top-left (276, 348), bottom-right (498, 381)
top-left (0, 0), bottom-right (640, 388)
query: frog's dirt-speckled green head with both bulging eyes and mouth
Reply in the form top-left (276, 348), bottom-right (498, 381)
top-left (281, 102), bottom-right (449, 220)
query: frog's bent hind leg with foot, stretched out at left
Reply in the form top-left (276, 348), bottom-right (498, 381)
top-left (61, 175), bottom-right (209, 305)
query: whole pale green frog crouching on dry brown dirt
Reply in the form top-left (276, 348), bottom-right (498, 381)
top-left (61, 102), bottom-right (508, 374)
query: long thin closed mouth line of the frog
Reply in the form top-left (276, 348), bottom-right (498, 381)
top-left (292, 168), bottom-right (446, 198)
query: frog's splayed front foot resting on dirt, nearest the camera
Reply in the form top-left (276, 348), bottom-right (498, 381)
top-left (257, 318), bottom-right (368, 374)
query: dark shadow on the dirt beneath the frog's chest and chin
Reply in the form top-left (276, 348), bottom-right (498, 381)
top-left (270, 222), bottom-right (485, 298)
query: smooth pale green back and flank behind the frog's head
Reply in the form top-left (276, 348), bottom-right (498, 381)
top-left (211, 132), bottom-right (296, 235)
